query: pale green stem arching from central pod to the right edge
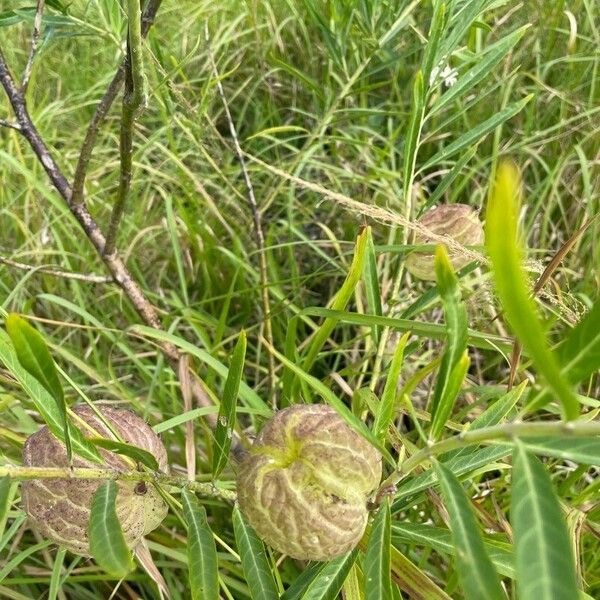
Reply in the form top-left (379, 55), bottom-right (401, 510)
top-left (377, 421), bottom-right (600, 500)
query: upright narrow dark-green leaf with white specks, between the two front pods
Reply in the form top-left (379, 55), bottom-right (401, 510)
top-left (213, 331), bottom-right (246, 479)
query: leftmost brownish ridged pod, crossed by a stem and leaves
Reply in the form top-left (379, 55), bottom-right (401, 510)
top-left (22, 405), bottom-right (168, 556)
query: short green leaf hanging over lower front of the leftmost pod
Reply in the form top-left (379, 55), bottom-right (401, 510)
top-left (89, 480), bottom-right (133, 578)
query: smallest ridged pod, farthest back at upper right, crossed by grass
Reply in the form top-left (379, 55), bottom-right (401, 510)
top-left (406, 204), bottom-right (484, 281)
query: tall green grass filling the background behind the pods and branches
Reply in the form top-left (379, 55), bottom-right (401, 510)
top-left (0, 0), bottom-right (600, 600)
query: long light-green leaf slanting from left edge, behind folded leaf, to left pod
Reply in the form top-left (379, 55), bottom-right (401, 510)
top-left (0, 329), bottom-right (103, 464)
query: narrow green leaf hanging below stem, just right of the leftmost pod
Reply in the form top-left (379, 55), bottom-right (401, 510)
top-left (181, 489), bottom-right (219, 600)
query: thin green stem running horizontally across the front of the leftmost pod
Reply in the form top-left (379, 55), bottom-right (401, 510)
top-left (0, 466), bottom-right (236, 502)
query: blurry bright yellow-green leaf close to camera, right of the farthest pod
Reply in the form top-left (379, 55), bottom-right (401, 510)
top-left (485, 163), bottom-right (579, 419)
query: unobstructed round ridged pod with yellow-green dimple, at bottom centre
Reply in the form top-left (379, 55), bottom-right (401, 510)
top-left (237, 404), bottom-right (381, 561)
